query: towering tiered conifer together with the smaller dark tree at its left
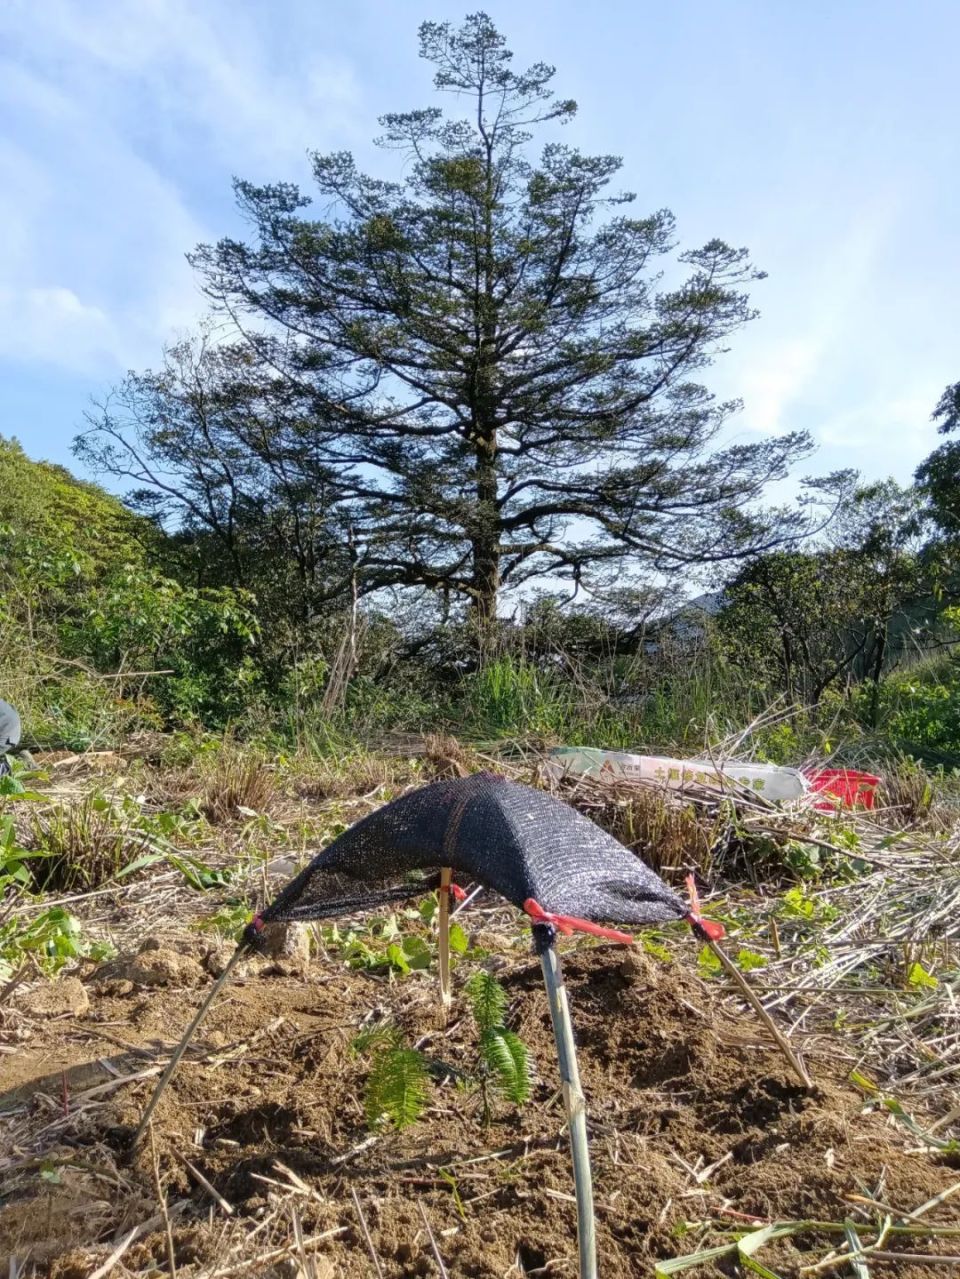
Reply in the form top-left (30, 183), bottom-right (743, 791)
top-left (82, 14), bottom-right (828, 644)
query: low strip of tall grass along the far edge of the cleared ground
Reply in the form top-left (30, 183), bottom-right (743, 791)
top-left (11, 588), bottom-right (960, 767)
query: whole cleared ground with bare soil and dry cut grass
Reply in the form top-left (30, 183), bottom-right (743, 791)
top-left (0, 743), bottom-right (960, 1279)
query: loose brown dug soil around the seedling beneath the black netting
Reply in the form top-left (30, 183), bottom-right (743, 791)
top-left (0, 945), bottom-right (960, 1279)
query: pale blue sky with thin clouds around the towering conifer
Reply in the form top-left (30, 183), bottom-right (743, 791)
top-left (0, 0), bottom-right (960, 491)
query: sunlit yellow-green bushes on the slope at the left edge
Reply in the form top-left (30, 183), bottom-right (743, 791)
top-left (0, 440), bottom-right (257, 747)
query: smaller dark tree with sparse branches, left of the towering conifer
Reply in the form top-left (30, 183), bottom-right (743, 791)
top-left (77, 331), bottom-right (353, 647)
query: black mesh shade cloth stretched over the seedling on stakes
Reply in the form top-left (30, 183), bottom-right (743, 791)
top-left (245, 773), bottom-right (689, 941)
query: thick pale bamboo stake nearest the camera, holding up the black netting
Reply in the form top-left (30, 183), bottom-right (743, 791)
top-left (533, 923), bottom-right (597, 1279)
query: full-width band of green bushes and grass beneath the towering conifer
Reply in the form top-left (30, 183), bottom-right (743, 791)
top-left (0, 429), bottom-right (960, 764)
